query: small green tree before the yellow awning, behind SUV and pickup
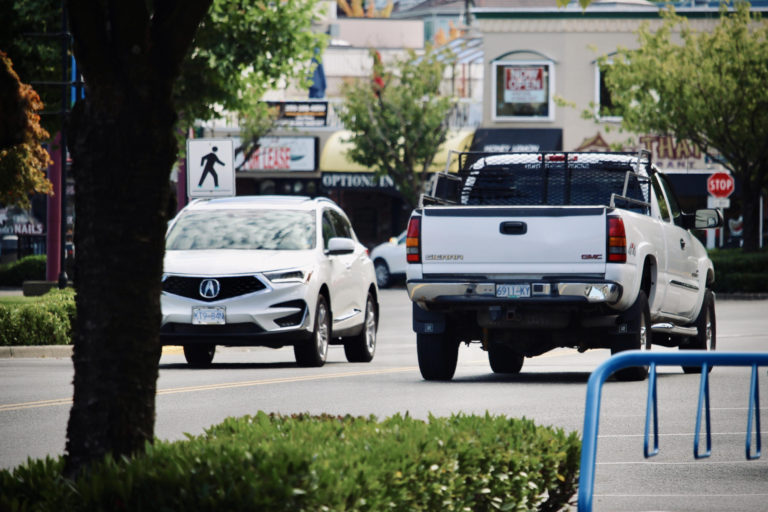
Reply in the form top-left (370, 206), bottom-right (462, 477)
top-left (339, 47), bottom-right (455, 207)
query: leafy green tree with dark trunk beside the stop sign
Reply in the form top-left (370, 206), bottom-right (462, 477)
top-left (600, 2), bottom-right (768, 249)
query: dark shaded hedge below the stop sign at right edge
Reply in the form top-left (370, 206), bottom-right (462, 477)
top-left (709, 249), bottom-right (768, 293)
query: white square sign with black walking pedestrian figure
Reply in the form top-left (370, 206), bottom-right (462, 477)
top-left (186, 139), bottom-right (235, 198)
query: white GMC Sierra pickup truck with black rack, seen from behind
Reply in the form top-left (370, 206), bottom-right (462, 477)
top-left (406, 152), bottom-right (723, 380)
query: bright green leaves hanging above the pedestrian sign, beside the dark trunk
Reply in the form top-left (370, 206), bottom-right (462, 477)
top-left (174, 0), bottom-right (325, 128)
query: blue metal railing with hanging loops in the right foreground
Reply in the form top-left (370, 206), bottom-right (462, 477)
top-left (578, 350), bottom-right (768, 512)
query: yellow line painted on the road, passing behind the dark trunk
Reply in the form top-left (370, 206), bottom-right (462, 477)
top-left (0, 366), bottom-right (418, 412)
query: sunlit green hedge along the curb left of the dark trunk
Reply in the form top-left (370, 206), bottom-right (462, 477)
top-left (0, 289), bottom-right (75, 345)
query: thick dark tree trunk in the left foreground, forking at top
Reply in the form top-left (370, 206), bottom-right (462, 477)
top-left (65, 0), bottom-right (211, 477)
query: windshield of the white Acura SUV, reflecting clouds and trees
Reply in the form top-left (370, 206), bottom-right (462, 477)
top-left (165, 210), bottom-right (315, 251)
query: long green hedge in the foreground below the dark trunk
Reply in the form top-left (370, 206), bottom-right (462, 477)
top-left (0, 412), bottom-right (580, 512)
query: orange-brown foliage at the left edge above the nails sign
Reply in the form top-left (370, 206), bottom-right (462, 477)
top-left (0, 51), bottom-right (53, 208)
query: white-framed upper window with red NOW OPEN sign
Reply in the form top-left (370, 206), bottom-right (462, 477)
top-left (493, 61), bottom-right (555, 121)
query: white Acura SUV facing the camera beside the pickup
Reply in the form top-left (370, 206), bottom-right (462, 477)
top-left (160, 196), bottom-right (379, 367)
